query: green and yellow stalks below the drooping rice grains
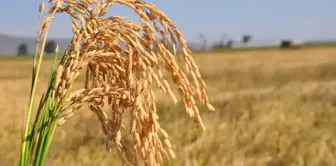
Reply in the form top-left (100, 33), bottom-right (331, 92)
top-left (20, 1), bottom-right (61, 166)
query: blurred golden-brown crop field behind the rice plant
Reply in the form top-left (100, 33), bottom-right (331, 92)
top-left (0, 48), bottom-right (336, 166)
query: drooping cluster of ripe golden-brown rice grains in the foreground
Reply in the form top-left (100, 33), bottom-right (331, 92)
top-left (40, 0), bottom-right (214, 165)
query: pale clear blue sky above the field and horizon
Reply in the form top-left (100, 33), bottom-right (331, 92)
top-left (0, 0), bottom-right (336, 41)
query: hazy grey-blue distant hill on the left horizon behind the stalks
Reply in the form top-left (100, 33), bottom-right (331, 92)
top-left (0, 34), bottom-right (70, 56)
